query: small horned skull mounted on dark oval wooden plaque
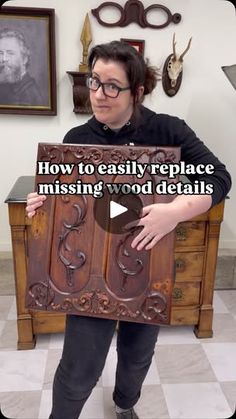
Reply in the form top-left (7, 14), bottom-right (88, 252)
top-left (162, 34), bottom-right (192, 96)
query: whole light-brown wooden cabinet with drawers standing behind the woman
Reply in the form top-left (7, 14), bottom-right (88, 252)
top-left (6, 176), bottom-right (224, 349)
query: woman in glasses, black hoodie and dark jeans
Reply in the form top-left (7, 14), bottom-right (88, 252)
top-left (26, 41), bottom-right (231, 419)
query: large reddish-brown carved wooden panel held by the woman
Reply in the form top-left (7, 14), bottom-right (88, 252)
top-left (26, 143), bottom-right (180, 324)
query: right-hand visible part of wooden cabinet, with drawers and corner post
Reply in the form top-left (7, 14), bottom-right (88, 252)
top-left (171, 208), bottom-right (224, 338)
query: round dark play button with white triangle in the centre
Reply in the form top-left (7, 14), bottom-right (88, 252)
top-left (94, 188), bottom-right (143, 234)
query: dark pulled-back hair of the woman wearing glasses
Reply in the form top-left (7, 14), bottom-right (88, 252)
top-left (88, 41), bottom-right (159, 104)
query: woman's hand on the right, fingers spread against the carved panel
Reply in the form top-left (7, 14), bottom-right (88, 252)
top-left (131, 204), bottom-right (178, 250)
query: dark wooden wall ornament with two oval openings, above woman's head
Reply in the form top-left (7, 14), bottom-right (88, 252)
top-left (91, 0), bottom-right (181, 29)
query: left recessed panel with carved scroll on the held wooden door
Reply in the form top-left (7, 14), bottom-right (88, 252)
top-left (50, 195), bottom-right (94, 293)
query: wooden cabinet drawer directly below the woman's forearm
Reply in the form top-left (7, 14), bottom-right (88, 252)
top-left (175, 221), bottom-right (206, 248)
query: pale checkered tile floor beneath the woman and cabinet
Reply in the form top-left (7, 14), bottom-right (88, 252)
top-left (0, 290), bottom-right (236, 419)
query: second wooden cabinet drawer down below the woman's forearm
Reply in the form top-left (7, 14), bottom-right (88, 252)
top-left (175, 252), bottom-right (204, 282)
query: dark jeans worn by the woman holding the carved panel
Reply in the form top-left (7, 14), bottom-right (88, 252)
top-left (50, 315), bottom-right (159, 419)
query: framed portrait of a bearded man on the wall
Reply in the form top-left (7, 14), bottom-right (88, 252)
top-left (0, 7), bottom-right (57, 115)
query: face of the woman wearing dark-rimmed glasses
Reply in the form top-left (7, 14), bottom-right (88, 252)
top-left (90, 59), bottom-right (133, 129)
